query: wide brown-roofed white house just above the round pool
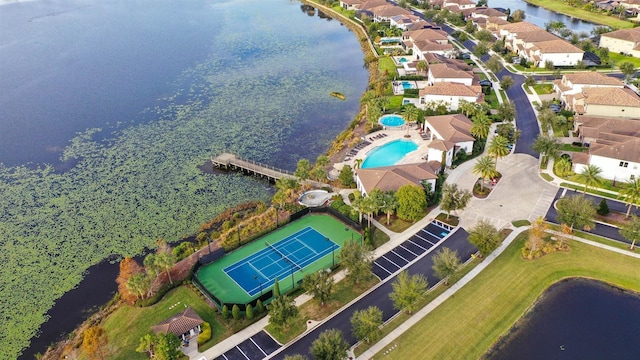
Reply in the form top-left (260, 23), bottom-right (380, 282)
top-left (417, 82), bottom-right (484, 111)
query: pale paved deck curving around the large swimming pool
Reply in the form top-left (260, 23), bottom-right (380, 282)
top-left (332, 125), bottom-right (431, 173)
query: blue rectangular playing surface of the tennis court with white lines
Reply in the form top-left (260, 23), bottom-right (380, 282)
top-left (224, 226), bottom-right (340, 296)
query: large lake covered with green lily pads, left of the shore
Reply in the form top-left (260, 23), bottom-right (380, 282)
top-left (0, 0), bottom-right (368, 359)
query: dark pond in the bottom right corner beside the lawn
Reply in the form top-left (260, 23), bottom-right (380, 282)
top-left (488, 279), bottom-right (640, 360)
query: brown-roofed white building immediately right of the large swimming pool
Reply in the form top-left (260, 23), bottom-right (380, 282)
top-left (423, 114), bottom-right (475, 166)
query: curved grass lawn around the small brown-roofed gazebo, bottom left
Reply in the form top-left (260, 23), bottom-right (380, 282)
top-left (103, 286), bottom-right (225, 360)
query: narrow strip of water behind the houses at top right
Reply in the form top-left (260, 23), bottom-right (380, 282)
top-left (489, 0), bottom-right (598, 34)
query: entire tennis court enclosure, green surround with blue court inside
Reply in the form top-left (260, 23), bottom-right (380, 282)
top-left (195, 214), bottom-right (361, 307)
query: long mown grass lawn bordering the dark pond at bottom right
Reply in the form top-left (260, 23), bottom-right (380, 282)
top-left (376, 233), bottom-right (640, 359)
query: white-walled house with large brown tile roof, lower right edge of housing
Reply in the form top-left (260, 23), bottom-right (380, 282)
top-left (573, 116), bottom-right (640, 181)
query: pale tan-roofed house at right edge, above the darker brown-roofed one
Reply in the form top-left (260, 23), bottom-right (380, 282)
top-left (567, 87), bottom-right (640, 118)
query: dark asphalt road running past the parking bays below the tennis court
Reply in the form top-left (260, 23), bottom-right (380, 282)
top-left (273, 228), bottom-right (476, 359)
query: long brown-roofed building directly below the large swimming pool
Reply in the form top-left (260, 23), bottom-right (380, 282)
top-left (356, 161), bottom-right (441, 196)
